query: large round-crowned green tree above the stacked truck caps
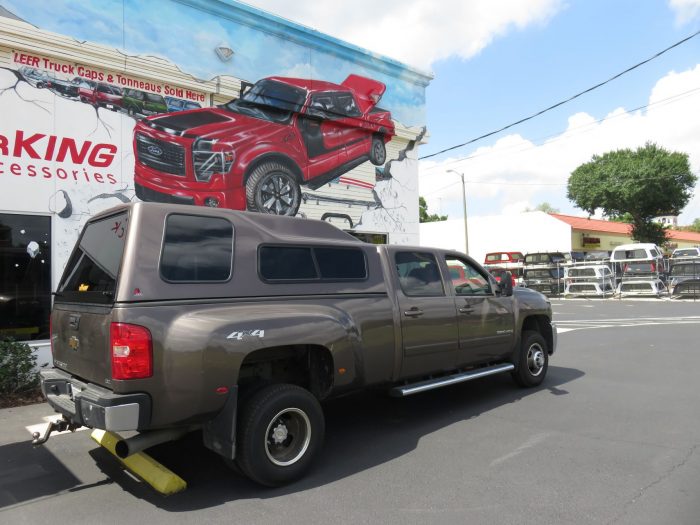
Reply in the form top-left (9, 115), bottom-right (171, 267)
top-left (566, 142), bottom-right (697, 245)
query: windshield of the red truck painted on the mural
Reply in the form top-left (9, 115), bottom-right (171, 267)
top-left (224, 80), bottom-right (306, 124)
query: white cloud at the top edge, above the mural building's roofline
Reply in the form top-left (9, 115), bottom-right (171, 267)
top-left (241, 0), bottom-right (562, 70)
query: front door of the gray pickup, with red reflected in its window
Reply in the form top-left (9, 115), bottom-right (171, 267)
top-left (445, 255), bottom-right (515, 366)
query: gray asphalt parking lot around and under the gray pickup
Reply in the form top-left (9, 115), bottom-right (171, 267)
top-left (0, 299), bottom-right (700, 525)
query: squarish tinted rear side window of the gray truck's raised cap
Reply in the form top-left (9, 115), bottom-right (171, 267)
top-left (160, 215), bottom-right (233, 282)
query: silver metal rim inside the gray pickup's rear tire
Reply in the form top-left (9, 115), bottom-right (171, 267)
top-left (265, 408), bottom-right (311, 467)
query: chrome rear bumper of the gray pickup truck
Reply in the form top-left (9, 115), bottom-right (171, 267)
top-left (39, 368), bottom-right (151, 431)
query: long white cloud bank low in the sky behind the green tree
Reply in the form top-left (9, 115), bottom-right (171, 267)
top-left (420, 64), bottom-right (700, 224)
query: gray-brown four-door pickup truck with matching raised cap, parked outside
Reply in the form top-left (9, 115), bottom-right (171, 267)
top-left (34, 203), bottom-right (557, 486)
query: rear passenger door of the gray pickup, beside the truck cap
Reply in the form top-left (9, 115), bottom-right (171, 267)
top-left (394, 251), bottom-right (457, 377)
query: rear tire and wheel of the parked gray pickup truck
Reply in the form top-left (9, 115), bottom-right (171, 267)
top-left (236, 384), bottom-right (325, 487)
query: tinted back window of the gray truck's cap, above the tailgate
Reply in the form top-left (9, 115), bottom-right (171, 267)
top-left (57, 213), bottom-right (129, 304)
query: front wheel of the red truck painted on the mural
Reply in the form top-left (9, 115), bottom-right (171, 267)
top-left (245, 162), bottom-right (301, 217)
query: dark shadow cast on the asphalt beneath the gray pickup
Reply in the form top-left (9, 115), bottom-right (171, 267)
top-left (85, 366), bottom-right (584, 512)
